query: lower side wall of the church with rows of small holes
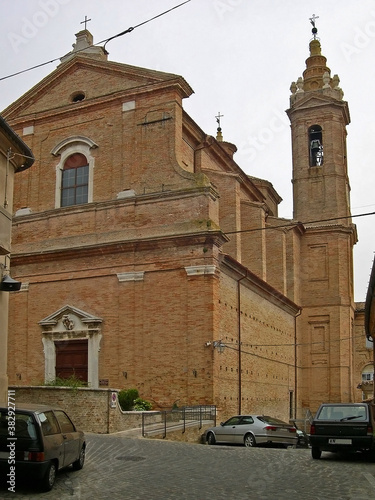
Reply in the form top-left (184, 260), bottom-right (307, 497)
top-left (213, 258), bottom-right (298, 420)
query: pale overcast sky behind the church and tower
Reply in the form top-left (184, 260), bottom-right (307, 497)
top-left (0, 0), bottom-right (375, 301)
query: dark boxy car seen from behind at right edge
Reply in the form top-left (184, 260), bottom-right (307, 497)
top-left (309, 403), bottom-right (375, 459)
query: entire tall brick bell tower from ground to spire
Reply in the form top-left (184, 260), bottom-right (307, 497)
top-left (287, 15), bottom-right (357, 412)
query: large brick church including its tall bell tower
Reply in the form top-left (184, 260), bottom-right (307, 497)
top-left (2, 22), bottom-right (373, 419)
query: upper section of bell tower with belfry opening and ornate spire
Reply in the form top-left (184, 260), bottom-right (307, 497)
top-left (287, 21), bottom-right (351, 224)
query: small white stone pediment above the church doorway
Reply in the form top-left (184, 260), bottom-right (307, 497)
top-left (39, 305), bottom-right (103, 333)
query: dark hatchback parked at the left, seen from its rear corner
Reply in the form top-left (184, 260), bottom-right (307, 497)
top-left (0, 404), bottom-right (86, 491)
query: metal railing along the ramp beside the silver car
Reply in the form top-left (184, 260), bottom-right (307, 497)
top-left (142, 405), bottom-right (216, 439)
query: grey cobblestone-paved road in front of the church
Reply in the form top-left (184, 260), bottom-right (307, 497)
top-left (0, 434), bottom-right (375, 500)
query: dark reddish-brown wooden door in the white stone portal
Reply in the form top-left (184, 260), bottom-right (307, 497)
top-left (55, 339), bottom-right (88, 382)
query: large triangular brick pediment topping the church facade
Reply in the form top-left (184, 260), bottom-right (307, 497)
top-left (2, 55), bottom-right (193, 120)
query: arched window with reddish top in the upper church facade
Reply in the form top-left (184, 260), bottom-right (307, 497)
top-left (61, 153), bottom-right (89, 207)
